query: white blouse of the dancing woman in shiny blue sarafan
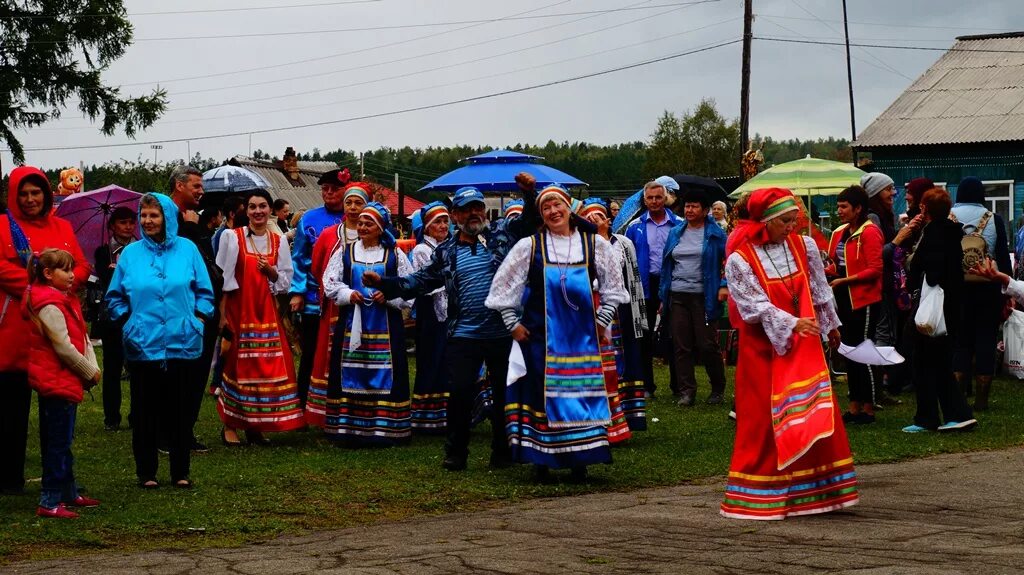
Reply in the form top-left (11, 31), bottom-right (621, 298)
top-left (484, 231), bottom-right (630, 328)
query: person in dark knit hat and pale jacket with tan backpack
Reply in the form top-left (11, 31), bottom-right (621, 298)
top-left (950, 176), bottom-right (1012, 410)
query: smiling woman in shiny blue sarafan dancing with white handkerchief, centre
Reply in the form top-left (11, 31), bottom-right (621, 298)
top-left (485, 185), bottom-right (629, 479)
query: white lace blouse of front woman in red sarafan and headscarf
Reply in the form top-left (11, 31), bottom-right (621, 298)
top-left (725, 237), bottom-right (841, 355)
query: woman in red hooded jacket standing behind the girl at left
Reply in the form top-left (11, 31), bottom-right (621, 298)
top-left (0, 166), bottom-right (89, 493)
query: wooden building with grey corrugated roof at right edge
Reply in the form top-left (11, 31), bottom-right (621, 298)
top-left (853, 32), bottom-right (1024, 230)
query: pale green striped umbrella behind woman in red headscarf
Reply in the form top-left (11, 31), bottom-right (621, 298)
top-left (729, 156), bottom-right (864, 198)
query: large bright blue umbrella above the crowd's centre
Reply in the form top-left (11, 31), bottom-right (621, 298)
top-left (420, 149), bottom-right (587, 192)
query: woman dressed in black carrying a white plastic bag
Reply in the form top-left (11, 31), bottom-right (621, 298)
top-left (903, 187), bottom-right (978, 433)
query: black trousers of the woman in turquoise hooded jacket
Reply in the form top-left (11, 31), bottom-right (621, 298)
top-left (128, 359), bottom-right (196, 481)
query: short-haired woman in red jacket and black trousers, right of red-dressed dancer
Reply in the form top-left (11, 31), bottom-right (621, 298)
top-left (825, 185), bottom-right (885, 424)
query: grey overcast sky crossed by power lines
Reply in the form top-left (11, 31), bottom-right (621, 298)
top-left (0, 0), bottom-right (1024, 171)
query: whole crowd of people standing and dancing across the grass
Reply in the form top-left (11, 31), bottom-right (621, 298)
top-left (0, 159), bottom-right (1007, 519)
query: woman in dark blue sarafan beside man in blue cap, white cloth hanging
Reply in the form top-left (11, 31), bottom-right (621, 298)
top-left (324, 202), bottom-right (413, 447)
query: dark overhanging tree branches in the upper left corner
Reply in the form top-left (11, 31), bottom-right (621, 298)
top-left (0, 0), bottom-right (167, 163)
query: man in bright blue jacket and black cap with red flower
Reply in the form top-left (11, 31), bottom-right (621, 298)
top-left (289, 169), bottom-right (356, 406)
